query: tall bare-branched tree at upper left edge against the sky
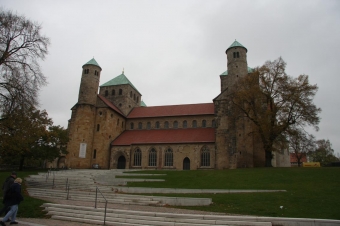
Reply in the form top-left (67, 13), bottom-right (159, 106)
top-left (0, 9), bottom-right (50, 112)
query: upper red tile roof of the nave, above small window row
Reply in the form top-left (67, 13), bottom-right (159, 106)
top-left (127, 103), bottom-right (214, 118)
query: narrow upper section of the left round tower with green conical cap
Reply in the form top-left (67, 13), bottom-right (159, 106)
top-left (78, 58), bottom-right (102, 105)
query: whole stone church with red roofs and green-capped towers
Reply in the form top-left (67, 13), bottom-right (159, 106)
top-left (63, 40), bottom-right (289, 170)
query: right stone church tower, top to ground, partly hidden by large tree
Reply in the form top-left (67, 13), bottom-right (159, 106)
top-left (213, 40), bottom-right (253, 169)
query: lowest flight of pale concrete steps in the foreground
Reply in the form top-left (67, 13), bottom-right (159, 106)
top-left (43, 203), bottom-right (272, 226)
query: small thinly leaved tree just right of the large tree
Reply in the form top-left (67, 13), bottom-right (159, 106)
top-left (287, 129), bottom-right (316, 167)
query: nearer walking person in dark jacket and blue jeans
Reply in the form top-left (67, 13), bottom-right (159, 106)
top-left (0, 178), bottom-right (24, 226)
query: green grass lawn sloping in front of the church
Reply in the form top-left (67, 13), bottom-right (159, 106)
top-left (119, 168), bottom-right (340, 219)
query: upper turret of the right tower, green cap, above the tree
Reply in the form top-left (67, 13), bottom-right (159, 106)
top-left (221, 40), bottom-right (248, 91)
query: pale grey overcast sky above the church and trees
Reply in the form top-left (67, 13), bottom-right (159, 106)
top-left (0, 0), bottom-right (340, 156)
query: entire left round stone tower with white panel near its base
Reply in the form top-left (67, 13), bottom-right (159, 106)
top-left (65, 58), bottom-right (102, 168)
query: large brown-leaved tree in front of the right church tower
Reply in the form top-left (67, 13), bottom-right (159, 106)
top-left (232, 58), bottom-right (321, 166)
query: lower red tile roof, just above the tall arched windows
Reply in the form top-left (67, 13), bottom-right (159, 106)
top-left (111, 128), bottom-right (215, 145)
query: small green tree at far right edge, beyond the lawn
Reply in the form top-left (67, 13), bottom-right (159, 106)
top-left (309, 139), bottom-right (339, 166)
